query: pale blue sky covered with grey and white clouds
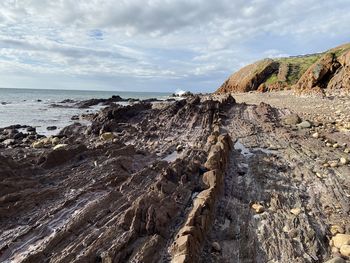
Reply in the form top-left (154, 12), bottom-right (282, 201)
top-left (0, 0), bottom-right (350, 92)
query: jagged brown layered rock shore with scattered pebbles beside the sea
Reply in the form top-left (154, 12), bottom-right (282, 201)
top-left (0, 93), bottom-right (350, 262)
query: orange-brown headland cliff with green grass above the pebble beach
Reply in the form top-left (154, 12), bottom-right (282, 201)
top-left (217, 44), bottom-right (350, 94)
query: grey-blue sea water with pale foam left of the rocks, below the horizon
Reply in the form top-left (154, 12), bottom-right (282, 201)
top-left (0, 88), bottom-right (170, 135)
